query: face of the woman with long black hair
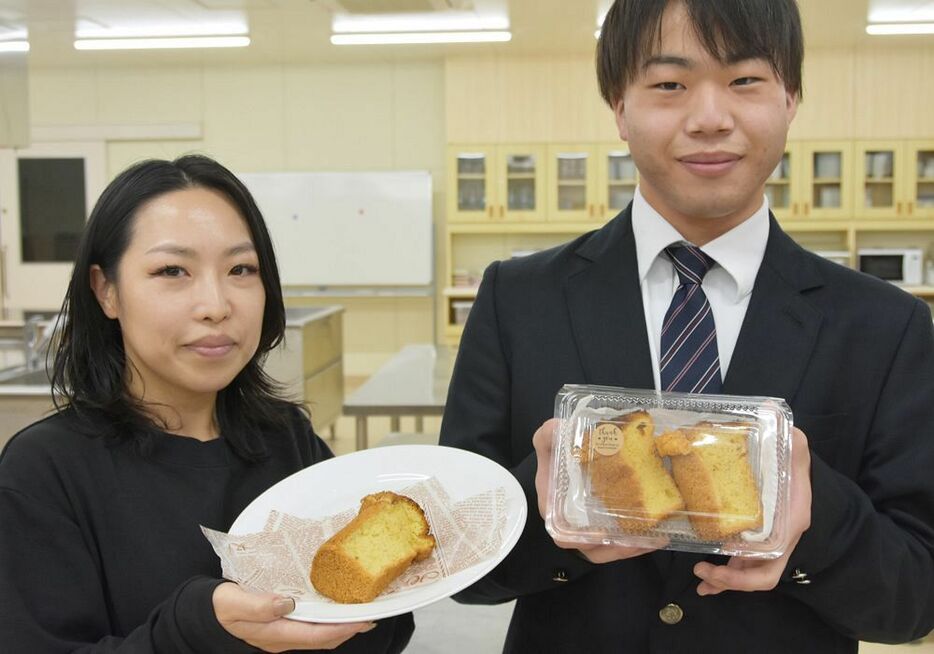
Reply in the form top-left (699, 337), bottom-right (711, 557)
top-left (91, 188), bottom-right (266, 407)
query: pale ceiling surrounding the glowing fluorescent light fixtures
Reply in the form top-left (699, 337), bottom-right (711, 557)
top-left (0, 0), bottom-right (934, 66)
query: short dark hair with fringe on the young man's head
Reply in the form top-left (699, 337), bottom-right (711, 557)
top-left (597, 0), bottom-right (804, 107)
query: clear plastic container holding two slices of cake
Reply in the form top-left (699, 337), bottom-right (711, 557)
top-left (545, 385), bottom-right (792, 558)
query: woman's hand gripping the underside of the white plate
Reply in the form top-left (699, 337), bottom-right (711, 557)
top-left (213, 582), bottom-right (376, 652)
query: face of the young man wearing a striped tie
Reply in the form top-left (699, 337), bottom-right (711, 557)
top-left (616, 2), bottom-right (797, 240)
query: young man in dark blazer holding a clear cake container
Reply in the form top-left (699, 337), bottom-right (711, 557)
top-left (441, 0), bottom-right (934, 654)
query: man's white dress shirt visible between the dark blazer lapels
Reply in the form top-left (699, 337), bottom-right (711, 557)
top-left (632, 188), bottom-right (769, 389)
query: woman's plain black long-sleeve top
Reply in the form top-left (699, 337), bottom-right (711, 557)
top-left (0, 410), bottom-right (414, 654)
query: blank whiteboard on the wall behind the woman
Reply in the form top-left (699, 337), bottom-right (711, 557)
top-left (238, 171), bottom-right (434, 287)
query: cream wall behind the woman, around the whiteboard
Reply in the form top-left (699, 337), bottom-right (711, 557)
top-left (23, 62), bottom-right (445, 375)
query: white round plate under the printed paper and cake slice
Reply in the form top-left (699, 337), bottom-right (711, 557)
top-left (230, 445), bottom-right (527, 622)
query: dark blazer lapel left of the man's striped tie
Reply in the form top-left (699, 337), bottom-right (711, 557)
top-left (565, 209), bottom-right (655, 388)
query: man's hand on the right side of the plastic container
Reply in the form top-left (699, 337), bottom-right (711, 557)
top-left (694, 429), bottom-right (811, 595)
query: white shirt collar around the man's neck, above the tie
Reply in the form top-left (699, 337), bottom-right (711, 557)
top-left (632, 187), bottom-right (769, 300)
